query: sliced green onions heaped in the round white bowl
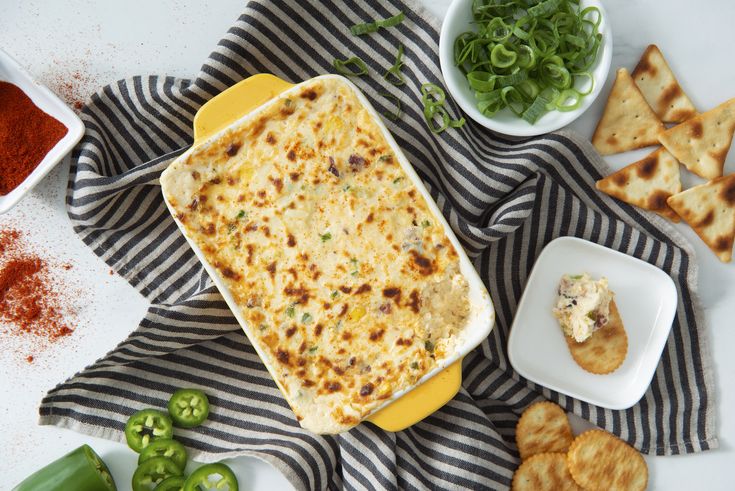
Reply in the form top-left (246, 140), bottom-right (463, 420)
top-left (454, 0), bottom-right (602, 127)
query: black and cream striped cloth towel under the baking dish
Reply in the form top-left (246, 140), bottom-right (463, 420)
top-left (40, 0), bottom-right (717, 489)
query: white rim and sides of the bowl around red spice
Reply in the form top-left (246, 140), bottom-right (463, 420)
top-left (0, 49), bottom-right (84, 213)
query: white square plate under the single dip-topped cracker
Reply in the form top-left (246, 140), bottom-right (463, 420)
top-left (508, 237), bottom-right (677, 409)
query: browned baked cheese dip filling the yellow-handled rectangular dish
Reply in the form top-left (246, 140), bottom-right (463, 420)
top-left (161, 77), bottom-right (470, 433)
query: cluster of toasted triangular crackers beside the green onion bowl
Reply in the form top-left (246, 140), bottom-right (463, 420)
top-left (596, 44), bottom-right (735, 264)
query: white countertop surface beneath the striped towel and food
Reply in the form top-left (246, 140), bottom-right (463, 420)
top-left (0, 0), bottom-right (735, 491)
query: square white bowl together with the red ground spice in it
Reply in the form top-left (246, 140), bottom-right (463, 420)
top-left (0, 49), bottom-right (84, 213)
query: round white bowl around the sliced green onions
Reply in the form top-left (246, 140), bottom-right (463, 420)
top-left (439, 0), bottom-right (612, 136)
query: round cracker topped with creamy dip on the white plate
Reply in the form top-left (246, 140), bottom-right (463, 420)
top-left (553, 273), bottom-right (628, 375)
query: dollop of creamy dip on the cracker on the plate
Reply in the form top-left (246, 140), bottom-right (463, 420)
top-left (553, 273), bottom-right (613, 343)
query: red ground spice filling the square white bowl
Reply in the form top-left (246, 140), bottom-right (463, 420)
top-left (0, 81), bottom-right (69, 195)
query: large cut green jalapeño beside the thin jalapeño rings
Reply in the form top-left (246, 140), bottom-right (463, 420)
top-left (13, 445), bottom-right (117, 491)
